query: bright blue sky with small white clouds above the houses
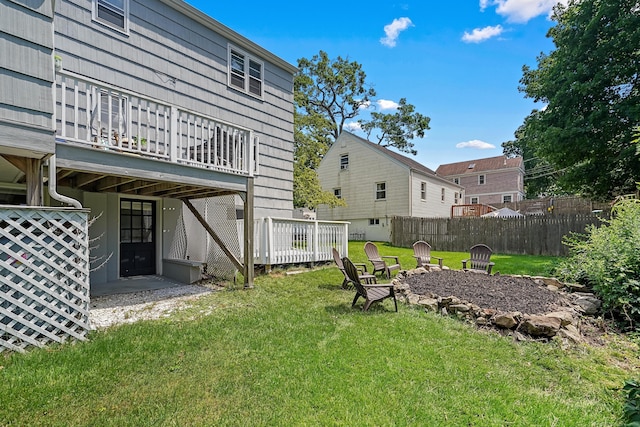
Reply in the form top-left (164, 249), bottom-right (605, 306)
top-left (187, 0), bottom-right (565, 170)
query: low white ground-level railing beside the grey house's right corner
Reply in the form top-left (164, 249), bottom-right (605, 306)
top-left (254, 218), bottom-right (349, 265)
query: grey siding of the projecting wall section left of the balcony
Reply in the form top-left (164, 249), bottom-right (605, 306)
top-left (0, 0), bottom-right (55, 157)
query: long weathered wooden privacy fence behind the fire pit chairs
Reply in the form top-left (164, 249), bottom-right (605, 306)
top-left (391, 214), bottom-right (602, 256)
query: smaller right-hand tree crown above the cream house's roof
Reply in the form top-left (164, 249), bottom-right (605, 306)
top-left (360, 98), bottom-right (431, 155)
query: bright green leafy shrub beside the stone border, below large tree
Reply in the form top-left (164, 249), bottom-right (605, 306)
top-left (558, 199), bottom-right (640, 328)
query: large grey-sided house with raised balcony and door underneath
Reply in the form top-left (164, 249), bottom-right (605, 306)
top-left (0, 0), bottom-right (297, 286)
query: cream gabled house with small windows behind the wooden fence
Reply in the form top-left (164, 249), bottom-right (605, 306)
top-left (317, 131), bottom-right (464, 241)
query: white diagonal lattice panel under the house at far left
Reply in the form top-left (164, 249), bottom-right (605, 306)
top-left (0, 206), bottom-right (89, 352)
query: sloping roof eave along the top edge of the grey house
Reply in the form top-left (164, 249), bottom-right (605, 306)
top-left (160, 0), bottom-right (298, 74)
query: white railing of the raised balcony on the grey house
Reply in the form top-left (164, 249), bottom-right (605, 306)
top-left (56, 71), bottom-right (259, 176)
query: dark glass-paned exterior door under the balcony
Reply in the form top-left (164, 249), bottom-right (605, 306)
top-left (120, 199), bottom-right (156, 277)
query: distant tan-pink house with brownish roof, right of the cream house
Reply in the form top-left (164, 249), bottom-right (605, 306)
top-left (436, 156), bottom-right (524, 205)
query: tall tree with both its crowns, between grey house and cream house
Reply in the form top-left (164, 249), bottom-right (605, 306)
top-left (293, 51), bottom-right (430, 208)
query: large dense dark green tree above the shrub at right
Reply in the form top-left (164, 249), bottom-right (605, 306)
top-left (515, 0), bottom-right (640, 199)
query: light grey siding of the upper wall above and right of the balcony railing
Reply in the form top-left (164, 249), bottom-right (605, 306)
top-left (55, 0), bottom-right (293, 217)
